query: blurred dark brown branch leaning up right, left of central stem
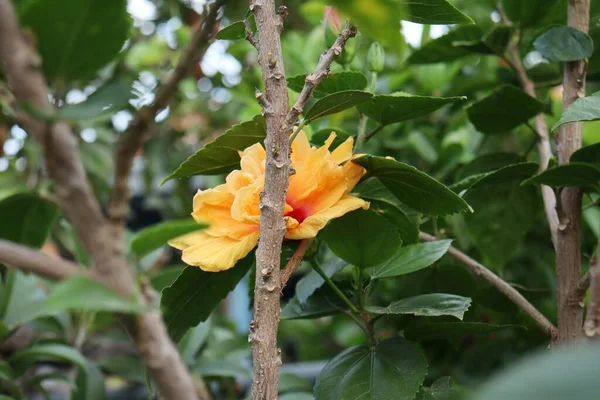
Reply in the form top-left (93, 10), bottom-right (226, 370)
top-left (108, 0), bottom-right (226, 231)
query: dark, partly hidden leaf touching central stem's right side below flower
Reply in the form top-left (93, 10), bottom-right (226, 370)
top-left (281, 284), bottom-right (350, 320)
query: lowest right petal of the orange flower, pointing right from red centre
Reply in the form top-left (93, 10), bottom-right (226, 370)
top-left (285, 195), bottom-right (369, 240)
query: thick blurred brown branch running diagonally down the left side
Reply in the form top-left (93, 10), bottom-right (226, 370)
top-left (0, 0), bottom-right (204, 400)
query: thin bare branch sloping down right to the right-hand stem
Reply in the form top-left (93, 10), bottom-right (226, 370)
top-left (419, 232), bottom-right (557, 339)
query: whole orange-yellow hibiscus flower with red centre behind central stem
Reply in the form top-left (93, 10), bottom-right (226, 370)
top-left (169, 132), bottom-right (369, 272)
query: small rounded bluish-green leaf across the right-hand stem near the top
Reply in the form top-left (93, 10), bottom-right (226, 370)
top-left (533, 26), bottom-right (594, 62)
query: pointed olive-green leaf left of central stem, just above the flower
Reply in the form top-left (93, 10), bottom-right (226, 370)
top-left (161, 116), bottom-right (267, 185)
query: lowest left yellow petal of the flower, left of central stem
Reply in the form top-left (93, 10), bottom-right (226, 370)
top-left (181, 231), bottom-right (259, 272)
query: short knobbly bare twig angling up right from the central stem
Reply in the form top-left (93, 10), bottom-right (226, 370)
top-left (286, 23), bottom-right (356, 127)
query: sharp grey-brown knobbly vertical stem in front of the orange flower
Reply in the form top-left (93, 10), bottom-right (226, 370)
top-left (250, 0), bottom-right (291, 400)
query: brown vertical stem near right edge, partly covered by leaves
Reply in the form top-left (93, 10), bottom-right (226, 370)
top-left (556, 0), bottom-right (590, 342)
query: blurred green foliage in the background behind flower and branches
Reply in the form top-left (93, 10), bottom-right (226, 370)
top-left (0, 0), bottom-right (600, 399)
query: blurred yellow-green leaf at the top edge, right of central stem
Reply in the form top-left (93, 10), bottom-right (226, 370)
top-left (330, 0), bottom-right (404, 46)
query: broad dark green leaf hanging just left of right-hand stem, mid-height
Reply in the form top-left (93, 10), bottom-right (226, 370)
top-left (464, 163), bottom-right (541, 269)
